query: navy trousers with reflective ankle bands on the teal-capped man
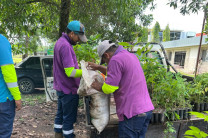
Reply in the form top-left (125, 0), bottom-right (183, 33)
top-left (54, 91), bottom-right (79, 138)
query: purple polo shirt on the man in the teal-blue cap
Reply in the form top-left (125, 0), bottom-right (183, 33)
top-left (53, 33), bottom-right (80, 94)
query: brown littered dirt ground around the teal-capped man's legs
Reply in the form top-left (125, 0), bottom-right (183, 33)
top-left (11, 90), bottom-right (90, 138)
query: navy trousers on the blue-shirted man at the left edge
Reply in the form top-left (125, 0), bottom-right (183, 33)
top-left (0, 100), bottom-right (15, 138)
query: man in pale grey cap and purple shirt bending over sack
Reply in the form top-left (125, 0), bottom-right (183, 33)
top-left (89, 40), bottom-right (154, 138)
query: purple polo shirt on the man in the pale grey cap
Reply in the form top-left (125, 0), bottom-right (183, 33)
top-left (106, 46), bottom-right (154, 121)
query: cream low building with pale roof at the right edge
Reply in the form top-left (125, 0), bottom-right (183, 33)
top-left (162, 35), bottom-right (208, 74)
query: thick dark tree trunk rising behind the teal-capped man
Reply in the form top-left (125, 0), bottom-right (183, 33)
top-left (59, 0), bottom-right (71, 37)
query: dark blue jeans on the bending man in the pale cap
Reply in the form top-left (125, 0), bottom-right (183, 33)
top-left (118, 111), bottom-right (152, 138)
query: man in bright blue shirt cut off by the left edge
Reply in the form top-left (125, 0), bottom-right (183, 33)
top-left (0, 34), bottom-right (21, 138)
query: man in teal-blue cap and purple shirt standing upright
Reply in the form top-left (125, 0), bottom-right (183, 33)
top-left (53, 21), bottom-right (87, 138)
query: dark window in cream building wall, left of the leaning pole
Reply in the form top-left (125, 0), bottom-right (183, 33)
top-left (174, 51), bottom-right (186, 67)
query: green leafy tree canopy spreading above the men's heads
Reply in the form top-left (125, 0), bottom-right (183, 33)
top-left (0, 0), bottom-right (153, 41)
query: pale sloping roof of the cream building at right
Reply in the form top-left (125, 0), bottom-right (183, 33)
top-left (161, 35), bottom-right (208, 48)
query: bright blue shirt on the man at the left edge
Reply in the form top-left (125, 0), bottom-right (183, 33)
top-left (0, 34), bottom-right (14, 103)
